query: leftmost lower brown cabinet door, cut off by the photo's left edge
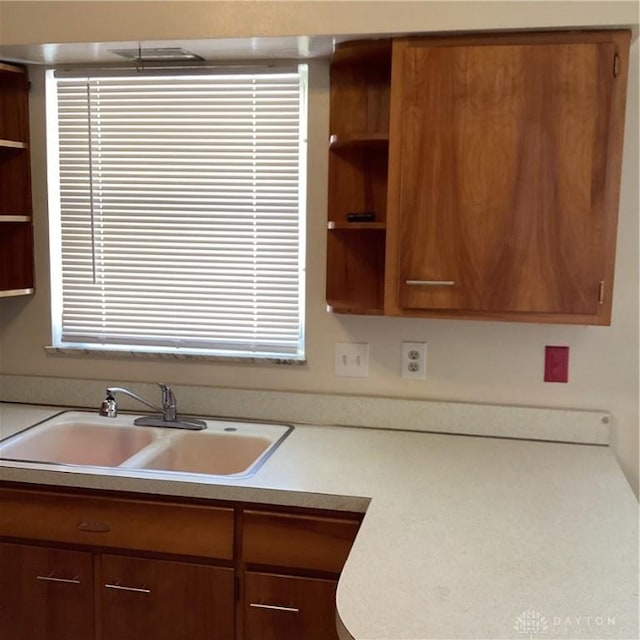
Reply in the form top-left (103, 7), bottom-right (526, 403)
top-left (0, 543), bottom-right (94, 640)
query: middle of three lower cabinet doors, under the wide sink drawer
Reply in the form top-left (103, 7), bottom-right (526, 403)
top-left (97, 555), bottom-right (234, 640)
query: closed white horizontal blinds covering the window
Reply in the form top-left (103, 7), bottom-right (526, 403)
top-left (49, 67), bottom-right (306, 359)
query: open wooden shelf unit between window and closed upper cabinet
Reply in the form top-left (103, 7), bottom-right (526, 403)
top-left (327, 39), bottom-right (391, 315)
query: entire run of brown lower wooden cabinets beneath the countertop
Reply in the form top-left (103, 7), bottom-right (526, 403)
top-left (0, 483), bottom-right (361, 640)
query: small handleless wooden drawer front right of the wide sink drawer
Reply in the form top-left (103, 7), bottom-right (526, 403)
top-left (242, 511), bottom-right (360, 573)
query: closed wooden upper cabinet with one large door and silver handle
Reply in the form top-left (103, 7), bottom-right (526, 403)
top-left (385, 31), bottom-right (629, 324)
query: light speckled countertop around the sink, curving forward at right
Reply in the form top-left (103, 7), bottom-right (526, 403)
top-left (0, 403), bottom-right (639, 640)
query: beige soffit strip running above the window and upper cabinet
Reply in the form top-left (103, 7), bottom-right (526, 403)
top-left (0, 0), bottom-right (638, 44)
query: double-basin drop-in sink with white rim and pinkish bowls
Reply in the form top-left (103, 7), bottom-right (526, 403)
top-left (0, 411), bottom-right (293, 476)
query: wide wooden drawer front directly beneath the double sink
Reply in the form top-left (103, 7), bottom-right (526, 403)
top-left (0, 489), bottom-right (233, 560)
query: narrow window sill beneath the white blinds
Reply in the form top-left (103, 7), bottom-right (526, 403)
top-left (44, 346), bottom-right (307, 367)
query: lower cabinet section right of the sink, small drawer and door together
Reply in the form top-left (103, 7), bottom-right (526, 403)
top-left (240, 509), bottom-right (360, 640)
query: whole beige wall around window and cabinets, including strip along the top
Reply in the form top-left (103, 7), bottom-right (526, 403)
top-left (0, 2), bottom-right (640, 491)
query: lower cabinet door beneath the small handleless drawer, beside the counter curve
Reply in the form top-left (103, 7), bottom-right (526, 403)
top-left (243, 572), bottom-right (338, 640)
